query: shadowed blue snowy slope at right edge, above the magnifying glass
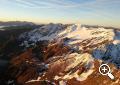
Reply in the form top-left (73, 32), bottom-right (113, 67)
top-left (93, 44), bottom-right (120, 68)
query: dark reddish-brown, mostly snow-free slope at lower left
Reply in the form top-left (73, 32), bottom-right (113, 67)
top-left (3, 44), bottom-right (69, 84)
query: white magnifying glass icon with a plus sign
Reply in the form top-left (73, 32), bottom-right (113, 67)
top-left (99, 64), bottom-right (115, 80)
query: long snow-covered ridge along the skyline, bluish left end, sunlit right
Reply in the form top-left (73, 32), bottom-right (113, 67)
top-left (20, 24), bottom-right (114, 48)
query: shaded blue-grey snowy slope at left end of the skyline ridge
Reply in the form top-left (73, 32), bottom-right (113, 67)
top-left (20, 24), bottom-right (64, 42)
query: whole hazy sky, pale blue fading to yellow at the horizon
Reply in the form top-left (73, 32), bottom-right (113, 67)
top-left (0, 0), bottom-right (120, 27)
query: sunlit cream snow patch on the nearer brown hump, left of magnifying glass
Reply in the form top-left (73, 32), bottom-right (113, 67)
top-left (54, 53), bottom-right (94, 81)
